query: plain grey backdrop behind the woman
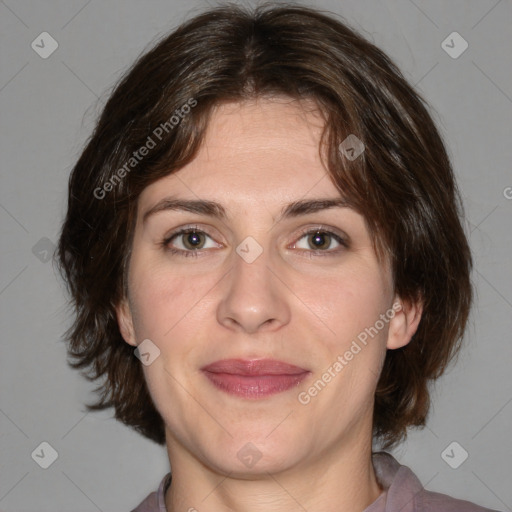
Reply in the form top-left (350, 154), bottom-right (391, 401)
top-left (0, 0), bottom-right (512, 512)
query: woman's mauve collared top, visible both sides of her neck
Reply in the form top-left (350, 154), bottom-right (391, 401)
top-left (131, 452), bottom-right (498, 512)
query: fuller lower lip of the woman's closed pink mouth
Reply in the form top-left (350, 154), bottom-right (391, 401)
top-left (204, 371), bottom-right (309, 398)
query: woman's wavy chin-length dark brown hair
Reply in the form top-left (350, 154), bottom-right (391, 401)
top-left (57, 3), bottom-right (472, 448)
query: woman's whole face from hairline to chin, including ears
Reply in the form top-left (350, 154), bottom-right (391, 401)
top-left (118, 99), bottom-right (415, 475)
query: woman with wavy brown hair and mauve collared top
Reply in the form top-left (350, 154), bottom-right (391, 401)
top-left (59, 5), bottom-right (500, 512)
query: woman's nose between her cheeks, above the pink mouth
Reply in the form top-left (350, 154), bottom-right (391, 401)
top-left (217, 241), bottom-right (290, 334)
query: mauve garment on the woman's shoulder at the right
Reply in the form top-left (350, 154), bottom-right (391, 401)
top-left (372, 452), bottom-right (499, 512)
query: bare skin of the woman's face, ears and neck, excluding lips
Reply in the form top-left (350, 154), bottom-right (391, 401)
top-left (117, 98), bottom-right (421, 512)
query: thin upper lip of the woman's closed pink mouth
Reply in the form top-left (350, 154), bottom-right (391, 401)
top-left (201, 359), bottom-right (308, 375)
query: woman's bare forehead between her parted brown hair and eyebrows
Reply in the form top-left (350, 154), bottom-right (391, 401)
top-left (140, 98), bottom-right (340, 211)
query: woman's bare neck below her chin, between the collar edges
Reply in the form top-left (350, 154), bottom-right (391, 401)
top-left (165, 430), bottom-right (383, 512)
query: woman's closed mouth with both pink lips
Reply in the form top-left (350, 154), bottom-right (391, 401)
top-left (201, 359), bottom-right (311, 399)
